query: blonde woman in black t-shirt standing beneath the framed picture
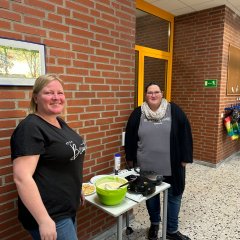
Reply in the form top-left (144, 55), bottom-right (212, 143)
top-left (11, 75), bottom-right (86, 240)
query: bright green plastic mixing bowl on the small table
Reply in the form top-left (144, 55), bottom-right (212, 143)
top-left (95, 175), bottom-right (127, 206)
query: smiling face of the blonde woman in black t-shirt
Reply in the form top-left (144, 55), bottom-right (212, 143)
top-left (34, 80), bottom-right (65, 115)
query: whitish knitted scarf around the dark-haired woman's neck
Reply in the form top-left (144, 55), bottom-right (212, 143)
top-left (141, 98), bottom-right (168, 121)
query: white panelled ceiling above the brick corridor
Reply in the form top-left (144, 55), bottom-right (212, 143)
top-left (137, 0), bottom-right (240, 16)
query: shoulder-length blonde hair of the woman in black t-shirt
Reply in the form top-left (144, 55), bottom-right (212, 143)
top-left (29, 74), bottom-right (64, 113)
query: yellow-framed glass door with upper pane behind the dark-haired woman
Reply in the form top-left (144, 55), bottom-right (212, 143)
top-left (135, 0), bottom-right (174, 106)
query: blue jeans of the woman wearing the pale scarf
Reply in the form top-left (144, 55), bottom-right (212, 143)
top-left (146, 188), bottom-right (182, 233)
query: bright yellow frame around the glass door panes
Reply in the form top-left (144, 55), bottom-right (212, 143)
top-left (135, 0), bottom-right (174, 106)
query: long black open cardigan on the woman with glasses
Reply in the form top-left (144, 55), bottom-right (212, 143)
top-left (125, 103), bottom-right (193, 195)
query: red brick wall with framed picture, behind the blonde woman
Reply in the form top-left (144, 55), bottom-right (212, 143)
top-left (0, 0), bottom-right (135, 240)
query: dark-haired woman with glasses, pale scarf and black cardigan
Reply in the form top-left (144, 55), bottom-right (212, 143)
top-left (125, 83), bottom-right (193, 240)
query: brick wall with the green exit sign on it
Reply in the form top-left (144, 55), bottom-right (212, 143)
top-left (172, 6), bottom-right (240, 164)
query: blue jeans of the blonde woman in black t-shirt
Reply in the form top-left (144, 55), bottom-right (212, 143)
top-left (28, 218), bottom-right (78, 240)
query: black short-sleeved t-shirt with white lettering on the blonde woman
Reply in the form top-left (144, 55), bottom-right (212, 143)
top-left (11, 114), bottom-right (86, 229)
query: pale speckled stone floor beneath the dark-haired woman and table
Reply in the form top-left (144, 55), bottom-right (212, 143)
top-left (106, 154), bottom-right (240, 240)
